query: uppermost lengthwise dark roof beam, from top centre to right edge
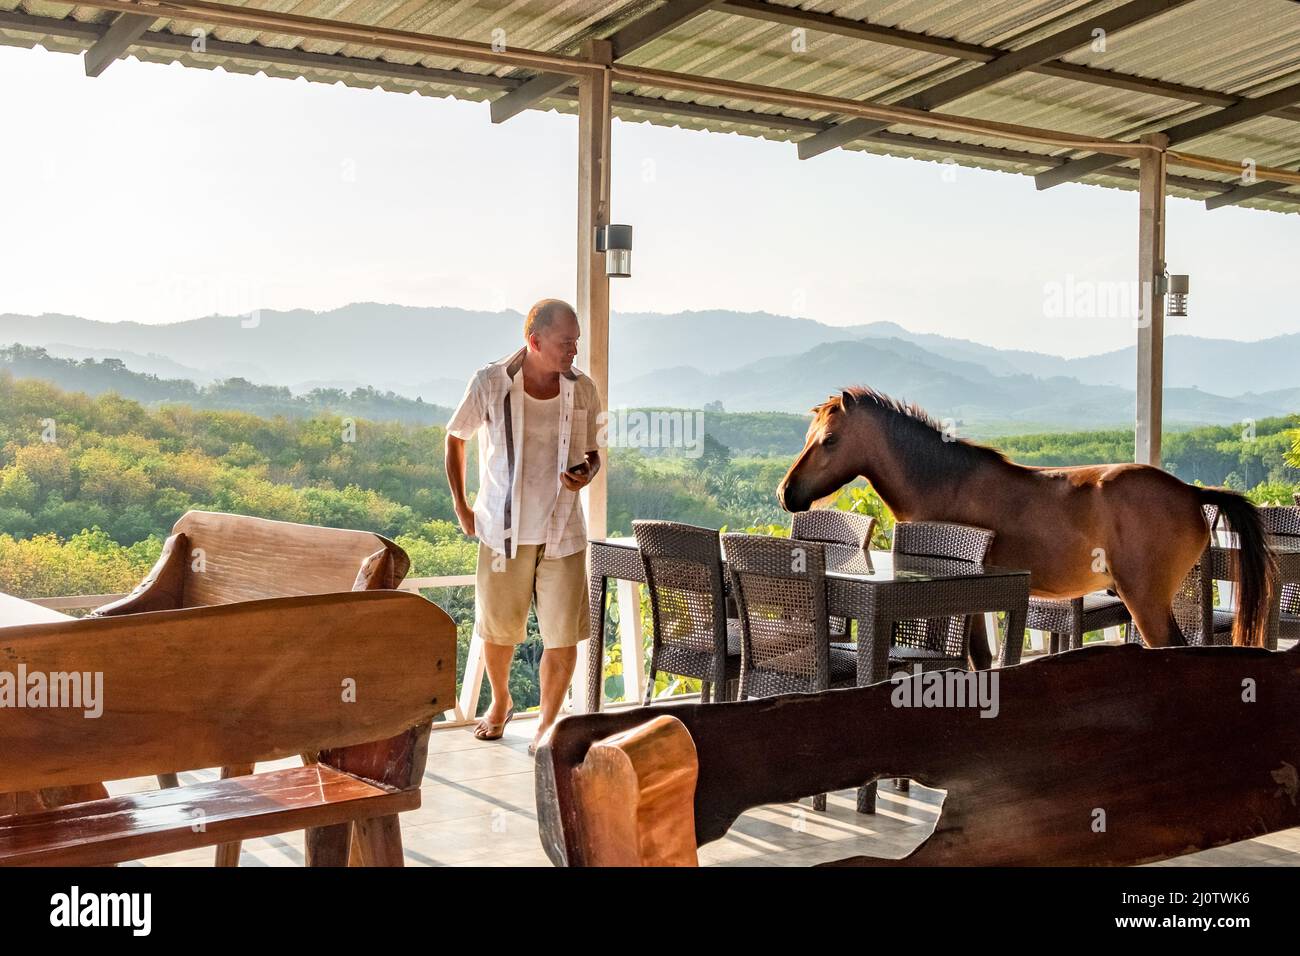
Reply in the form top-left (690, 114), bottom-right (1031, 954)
top-left (714, 0), bottom-right (1300, 121)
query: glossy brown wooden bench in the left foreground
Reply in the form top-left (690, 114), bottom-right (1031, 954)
top-left (0, 592), bottom-right (456, 866)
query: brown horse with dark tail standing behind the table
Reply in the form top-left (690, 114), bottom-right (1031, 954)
top-left (777, 388), bottom-right (1273, 666)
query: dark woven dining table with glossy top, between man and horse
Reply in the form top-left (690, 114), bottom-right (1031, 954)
top-left (586, 537), bottom-right (1030, 713)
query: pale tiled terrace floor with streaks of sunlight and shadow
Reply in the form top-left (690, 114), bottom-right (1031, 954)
top-left (111, 719), bottom-right (1300, 866)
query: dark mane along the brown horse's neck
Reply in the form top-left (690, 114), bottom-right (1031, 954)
top-left (813, 385), bottom-right (1006, 484)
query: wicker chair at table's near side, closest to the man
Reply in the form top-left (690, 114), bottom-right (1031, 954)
top-left (632, 522), bottom-right (741, 705)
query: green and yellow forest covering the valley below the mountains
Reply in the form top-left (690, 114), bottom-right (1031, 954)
top-left (0, 372), bottom-right (1300, 701)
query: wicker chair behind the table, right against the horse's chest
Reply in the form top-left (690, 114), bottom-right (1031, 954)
top-left (889, 522), bottom-right (993, 670)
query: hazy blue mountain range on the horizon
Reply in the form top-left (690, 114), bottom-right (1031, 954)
top-left (0, 303), bottom-right (1300, 433)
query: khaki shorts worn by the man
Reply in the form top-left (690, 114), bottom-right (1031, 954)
top-left (475, 541), bottom-right (589, 648)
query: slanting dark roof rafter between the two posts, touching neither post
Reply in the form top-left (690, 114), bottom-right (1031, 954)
top-left (798, 0), bottom-right (1190, 160)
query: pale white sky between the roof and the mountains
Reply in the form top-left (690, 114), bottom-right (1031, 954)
top-left (0, 38), bottom-right (1300, 355)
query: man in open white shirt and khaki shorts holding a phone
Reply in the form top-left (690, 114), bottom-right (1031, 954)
top-left (446, 299), bottom-right (601, 753)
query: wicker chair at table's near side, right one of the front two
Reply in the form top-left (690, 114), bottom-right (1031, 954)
top-left (723, 535), bottom-right (858, 810)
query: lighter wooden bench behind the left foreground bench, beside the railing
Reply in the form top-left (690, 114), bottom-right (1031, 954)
top-left (94, 511), bottom-right (411, 866)
